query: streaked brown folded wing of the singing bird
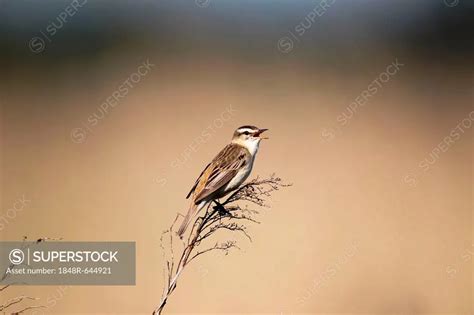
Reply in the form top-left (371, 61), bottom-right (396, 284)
top-left (194, 143), bottom-right (250, 204)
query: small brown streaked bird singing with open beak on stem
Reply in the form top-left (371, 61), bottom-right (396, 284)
top-left (178, 126), bottom-right (268, 238)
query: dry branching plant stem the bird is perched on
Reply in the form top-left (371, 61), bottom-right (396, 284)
top-left (153, 174), bottom-right (291, 315)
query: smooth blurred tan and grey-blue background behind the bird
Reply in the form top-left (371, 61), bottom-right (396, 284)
top-left (0, 0), bottom-right (474, 314)
